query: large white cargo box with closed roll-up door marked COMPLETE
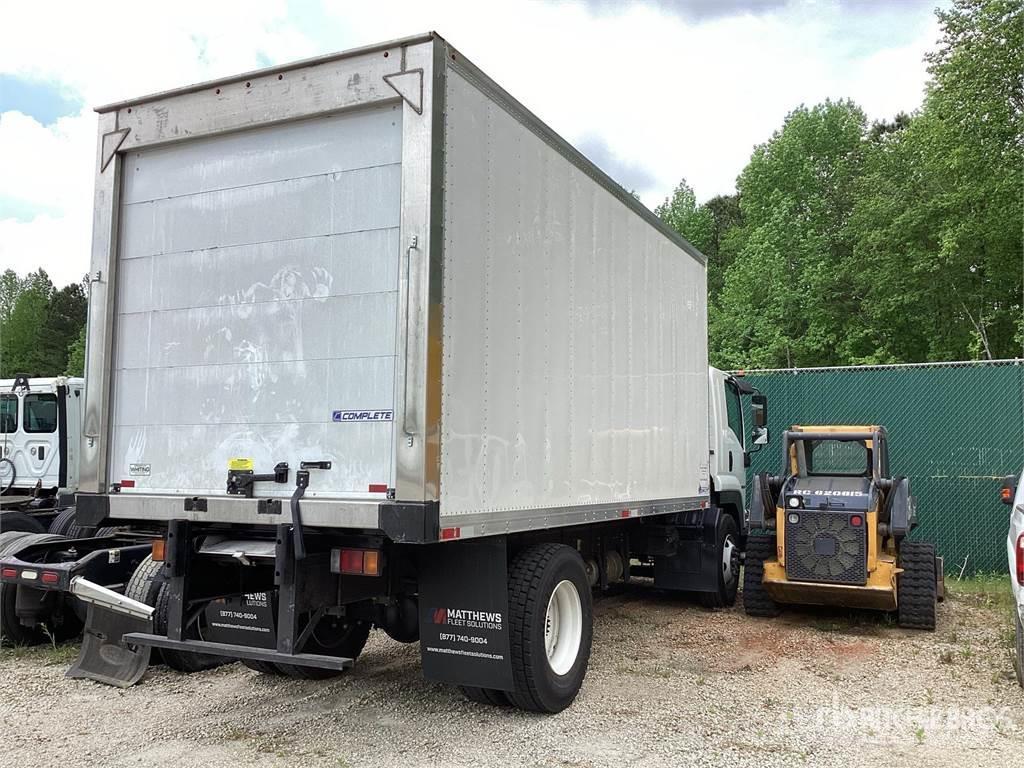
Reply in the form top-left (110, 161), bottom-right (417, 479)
top-left (80, 34), bottom-right (709, 541)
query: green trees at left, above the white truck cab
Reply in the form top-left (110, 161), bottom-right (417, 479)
top-left (0, 269), bottom-right (86, 379)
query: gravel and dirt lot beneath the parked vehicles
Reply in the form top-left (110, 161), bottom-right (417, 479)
top-left (0, 582), bottom-right (1024, 768)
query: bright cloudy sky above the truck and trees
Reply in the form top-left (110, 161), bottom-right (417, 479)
top-left (0, 0), bottom-right (947, 286)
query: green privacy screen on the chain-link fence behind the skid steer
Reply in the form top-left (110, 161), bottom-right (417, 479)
top-left (745, 360), bottom-right (1024, 573)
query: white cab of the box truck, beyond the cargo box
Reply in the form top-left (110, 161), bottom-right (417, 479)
top-left (708, 368), bottom-right (768, 539)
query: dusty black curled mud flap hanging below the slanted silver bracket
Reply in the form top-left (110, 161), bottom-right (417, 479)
top-left (67, 604), bottom-right (153, 688)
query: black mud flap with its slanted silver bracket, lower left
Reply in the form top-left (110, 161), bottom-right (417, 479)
top-left (68, 577), bottom-right (154, 688)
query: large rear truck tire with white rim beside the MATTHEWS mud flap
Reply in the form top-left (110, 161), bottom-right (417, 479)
top-left (508, 544), bottom-right (594, 714)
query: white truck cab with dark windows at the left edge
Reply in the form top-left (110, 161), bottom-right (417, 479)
top-left (0, 377), bottom-right (85, 499)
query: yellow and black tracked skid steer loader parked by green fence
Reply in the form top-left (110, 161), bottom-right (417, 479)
top-left (743, 426), bottom-right (943, 630)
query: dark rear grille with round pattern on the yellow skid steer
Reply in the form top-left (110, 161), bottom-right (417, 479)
top-left (785, 510), bottom-right (867, 585)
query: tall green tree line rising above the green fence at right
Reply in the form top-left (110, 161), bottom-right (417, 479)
top-left (656, 0), bottom-right (1024, 368)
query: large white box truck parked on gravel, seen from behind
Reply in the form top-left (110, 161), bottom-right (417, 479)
top-left (49, 34), bottom-right (764, 712)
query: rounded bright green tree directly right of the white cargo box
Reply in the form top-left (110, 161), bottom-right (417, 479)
top-left (710, 101), bottom-right (866, 368)
